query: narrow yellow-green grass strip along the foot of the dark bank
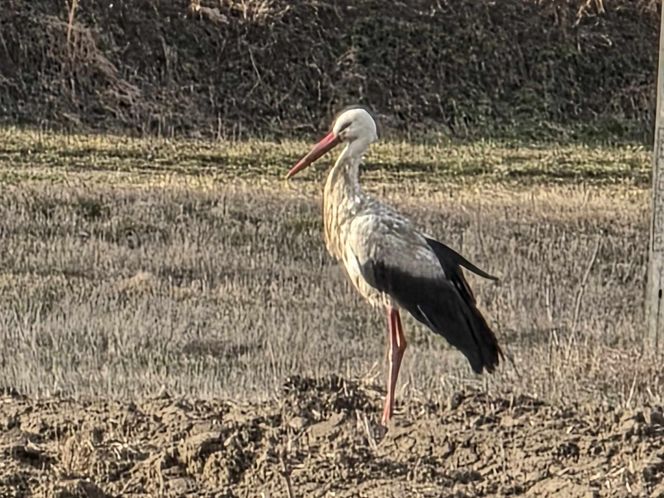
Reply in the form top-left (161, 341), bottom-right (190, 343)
top-left (0, 128), bottom-right (651, 186)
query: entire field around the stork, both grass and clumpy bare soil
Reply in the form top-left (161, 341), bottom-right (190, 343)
top-left (0, 129), bottom-right (664, 497)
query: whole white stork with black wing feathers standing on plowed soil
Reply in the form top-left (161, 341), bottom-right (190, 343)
top-left (286, 106), bottom-right (503, 426)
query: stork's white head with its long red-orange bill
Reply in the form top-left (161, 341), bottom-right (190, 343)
top-left (286, 106), bottom-right (378, 179)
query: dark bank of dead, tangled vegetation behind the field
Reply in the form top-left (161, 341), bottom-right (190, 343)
top-left (0, 0), bottom-right (659, 140)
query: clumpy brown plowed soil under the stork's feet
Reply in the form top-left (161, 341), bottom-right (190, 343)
top-left (0, 377), bottom-right (664, 497)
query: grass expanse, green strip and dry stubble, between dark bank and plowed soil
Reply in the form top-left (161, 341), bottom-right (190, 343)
top-left (0, 129), bottom-right (662, 404)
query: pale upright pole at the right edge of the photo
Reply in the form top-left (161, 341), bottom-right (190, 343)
top-left (646, 4), bottom-right (664, 353)
